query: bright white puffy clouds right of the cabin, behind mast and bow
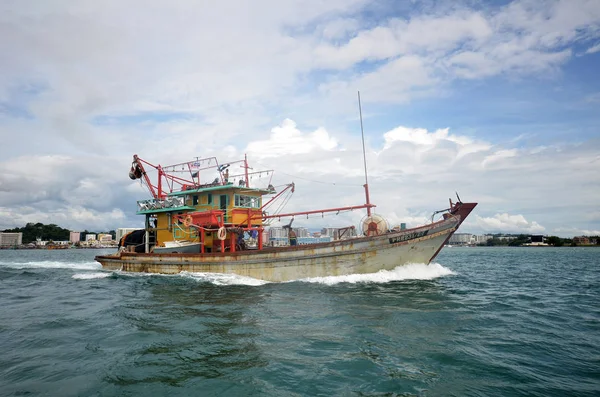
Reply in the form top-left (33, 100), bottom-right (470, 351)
top-left (243, 120), bottom-right (598, 237)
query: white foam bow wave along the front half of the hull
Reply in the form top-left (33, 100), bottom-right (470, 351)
top-left (297, 263), bottom-right (455, 285)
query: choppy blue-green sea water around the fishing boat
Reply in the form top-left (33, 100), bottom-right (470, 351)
top-left (0, 247), bottom-right (600, 397)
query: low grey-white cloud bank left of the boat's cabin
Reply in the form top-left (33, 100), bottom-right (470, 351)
top-left (0, 156), bottom-right (139, 230)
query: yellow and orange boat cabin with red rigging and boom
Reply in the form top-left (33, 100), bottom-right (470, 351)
top-left (123, 155), bottom-right (374, 253)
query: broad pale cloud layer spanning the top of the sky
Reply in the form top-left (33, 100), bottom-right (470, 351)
top-left (0, 0), bottom-right (600, 128)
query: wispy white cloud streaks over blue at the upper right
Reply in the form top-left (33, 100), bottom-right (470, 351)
top-left (315, 0), bottom-right (600, 102)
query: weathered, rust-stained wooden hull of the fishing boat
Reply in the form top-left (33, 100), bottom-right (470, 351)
top-left (96, 203), bottom-right (475, 282)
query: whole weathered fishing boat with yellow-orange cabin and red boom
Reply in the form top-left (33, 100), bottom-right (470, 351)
top-left (95, 97), bottom-right (477, 282)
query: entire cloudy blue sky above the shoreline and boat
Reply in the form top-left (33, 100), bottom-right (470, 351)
top-left (0, 0), bottom-right (600, 237)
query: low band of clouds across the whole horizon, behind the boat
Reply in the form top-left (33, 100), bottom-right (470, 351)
top-left (0, 119), bottom-right (598, 233)
